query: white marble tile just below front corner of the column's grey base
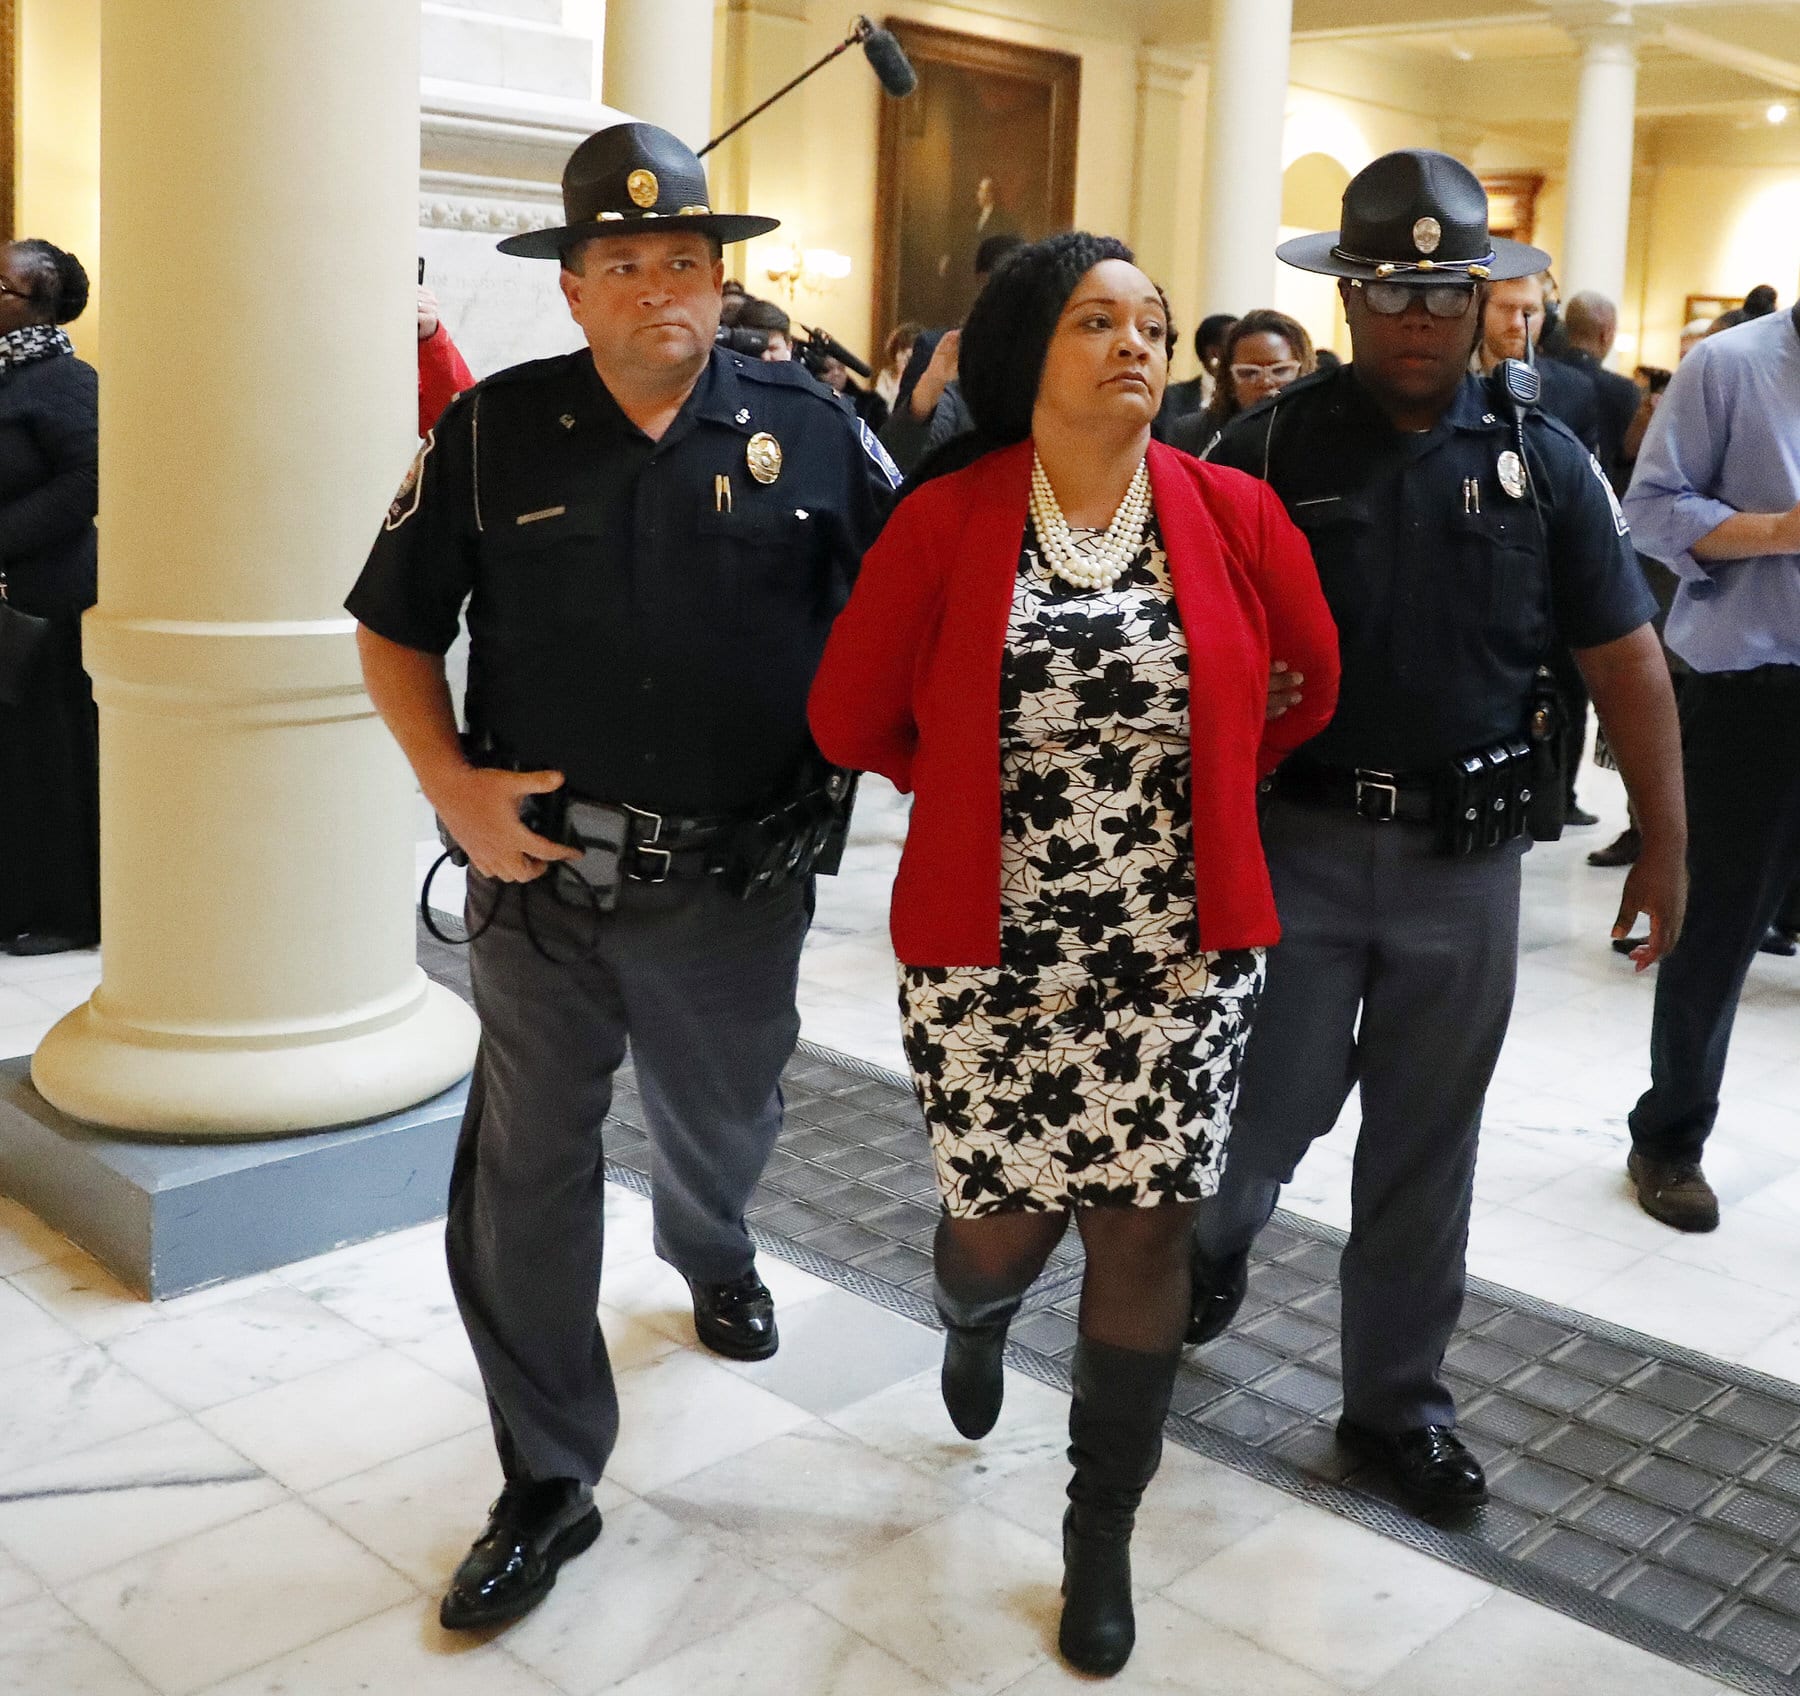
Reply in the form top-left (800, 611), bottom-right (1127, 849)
top-left (110, 1287), bottom-right (380, 1412)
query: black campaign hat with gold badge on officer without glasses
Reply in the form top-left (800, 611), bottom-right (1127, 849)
top-left (500, 124), bottom-right (781, 259)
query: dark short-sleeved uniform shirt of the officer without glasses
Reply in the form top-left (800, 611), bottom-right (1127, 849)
top-left (346, 349), bottom-right (900, 814)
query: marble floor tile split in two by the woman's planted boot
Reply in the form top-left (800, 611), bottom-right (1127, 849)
top-left (979, 1444), bottom-right (1292, 1595)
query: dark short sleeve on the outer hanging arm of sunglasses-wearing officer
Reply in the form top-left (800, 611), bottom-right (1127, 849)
top-left (1544, 430), bottom-right (1656, 648)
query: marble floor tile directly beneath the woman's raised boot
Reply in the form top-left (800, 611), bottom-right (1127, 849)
top-left (830, 1370), bottom-right (1069, 1496)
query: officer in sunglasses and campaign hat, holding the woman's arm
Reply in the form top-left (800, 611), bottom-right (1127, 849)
top-left (1190, 151), bottom-right (1685, 1512)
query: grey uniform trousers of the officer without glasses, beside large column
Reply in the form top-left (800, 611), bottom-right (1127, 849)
top-left (445, 875), bottom-right (812, 1484)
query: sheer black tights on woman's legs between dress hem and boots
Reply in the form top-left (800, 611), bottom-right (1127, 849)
top-left (936, 1203), bottom-right (1193, 1354)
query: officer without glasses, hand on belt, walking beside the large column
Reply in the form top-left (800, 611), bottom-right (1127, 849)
top-left (347, 124), bottom-right (898, 1628)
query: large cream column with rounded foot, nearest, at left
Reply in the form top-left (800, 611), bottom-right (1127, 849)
top-left (32, 0), bottom-right (475, 1138)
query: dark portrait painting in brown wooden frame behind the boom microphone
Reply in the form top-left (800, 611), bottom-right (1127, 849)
top-left (869, 18), bottom-right (1082, 347)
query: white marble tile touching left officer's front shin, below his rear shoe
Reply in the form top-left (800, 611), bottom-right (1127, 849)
top-left (608, 1349), bottom-right (808, 1496)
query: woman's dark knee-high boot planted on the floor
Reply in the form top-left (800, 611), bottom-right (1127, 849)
top-left (1058, 1338), bottom-right (1181, 1676)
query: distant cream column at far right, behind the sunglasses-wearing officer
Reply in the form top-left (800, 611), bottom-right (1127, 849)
top-left (1557, 22), bottom-right (1638, 304)
